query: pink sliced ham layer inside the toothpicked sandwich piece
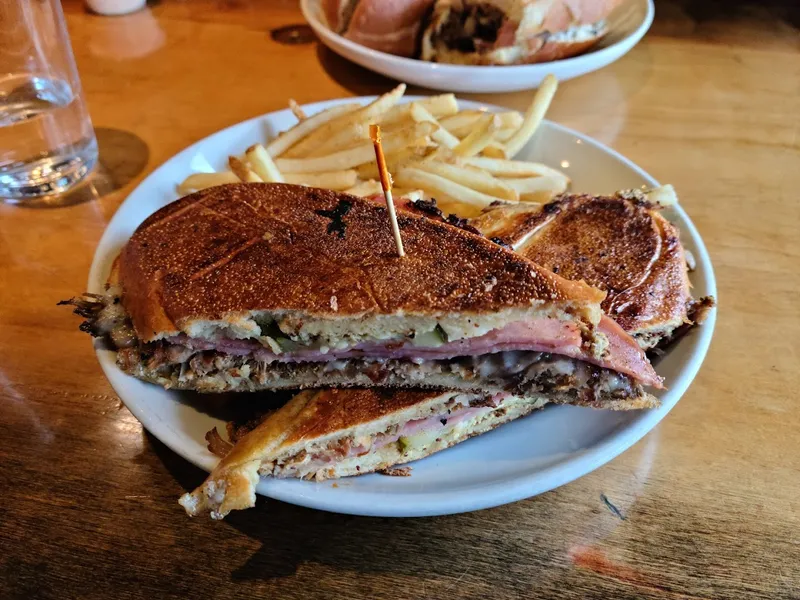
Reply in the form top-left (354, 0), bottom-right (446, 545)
top-left (164, 316), bottom-right (663, 388)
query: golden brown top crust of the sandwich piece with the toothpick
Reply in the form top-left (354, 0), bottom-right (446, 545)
top-left (120, 183), bottom-right (603, 341)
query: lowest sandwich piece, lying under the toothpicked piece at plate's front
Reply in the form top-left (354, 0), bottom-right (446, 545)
top-left (180, 389), bottom-right (636, 519)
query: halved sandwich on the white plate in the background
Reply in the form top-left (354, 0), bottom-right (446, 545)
top-left (322, 0), bottom-right (622, 65)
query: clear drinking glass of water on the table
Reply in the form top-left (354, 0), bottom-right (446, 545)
top-left (0, 0), bottom-right (97, 202)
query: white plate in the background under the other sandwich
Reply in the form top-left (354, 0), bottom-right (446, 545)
top-left (300, 0), bottom-right (655, 94)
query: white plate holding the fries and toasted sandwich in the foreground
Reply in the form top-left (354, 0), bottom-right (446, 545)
top-left (89, 97), bottom-right (717, 516)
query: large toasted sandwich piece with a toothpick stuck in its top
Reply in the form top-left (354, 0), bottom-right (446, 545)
top-left (66, 183), bottom-right (662, 407)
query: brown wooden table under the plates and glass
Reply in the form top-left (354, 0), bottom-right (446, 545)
top-left (0, 0), bottom-right (800, 600)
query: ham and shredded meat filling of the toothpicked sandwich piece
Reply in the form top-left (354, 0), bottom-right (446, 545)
top-left (61, 288), bottom-right (661, 404)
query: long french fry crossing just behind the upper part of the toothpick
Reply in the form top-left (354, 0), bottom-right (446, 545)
top-left (275, 123), bottom-right (437, 173)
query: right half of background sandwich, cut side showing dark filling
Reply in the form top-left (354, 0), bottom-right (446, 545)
top-left (421, 0), bottom-right (621, 65)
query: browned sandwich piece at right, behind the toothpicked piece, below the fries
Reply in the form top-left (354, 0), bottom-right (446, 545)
top-left (470, 190), bottom-right (714, 351)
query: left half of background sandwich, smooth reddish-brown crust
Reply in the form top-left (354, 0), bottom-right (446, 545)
top-left (322, 0), bottom-right (433, 57)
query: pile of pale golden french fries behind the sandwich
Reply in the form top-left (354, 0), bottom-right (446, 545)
top-left (178, 75), bottom-right (570, 217)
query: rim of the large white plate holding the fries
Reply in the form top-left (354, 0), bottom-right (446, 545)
top-left (88, 96), bottom-right (718, 517)
